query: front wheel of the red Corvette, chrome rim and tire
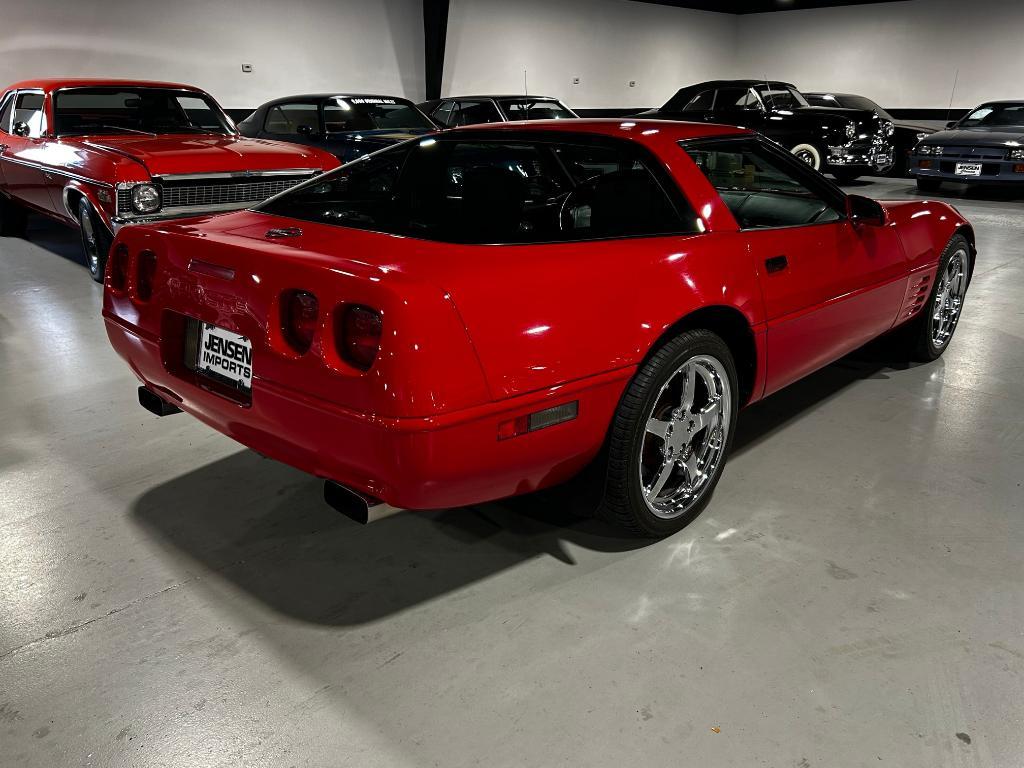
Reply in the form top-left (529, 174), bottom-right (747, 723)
top-left (902, 234), bottom-right (971, 362)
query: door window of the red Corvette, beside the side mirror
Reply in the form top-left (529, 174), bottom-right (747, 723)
top-left (684, 139), bottom-right (843, 229)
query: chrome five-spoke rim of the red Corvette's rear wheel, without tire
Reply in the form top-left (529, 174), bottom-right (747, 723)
top-left (638, 355), bottom-right (732, 519)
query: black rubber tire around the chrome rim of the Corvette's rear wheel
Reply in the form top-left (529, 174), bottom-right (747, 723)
top-left (599, 330), bottom-right (739, 538)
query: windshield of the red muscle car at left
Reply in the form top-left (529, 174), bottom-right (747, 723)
top-left (53, 87), bottom-right (234, 136)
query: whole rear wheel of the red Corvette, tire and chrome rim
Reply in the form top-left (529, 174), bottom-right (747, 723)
top-left (601, 330), bottom-right (739, 538)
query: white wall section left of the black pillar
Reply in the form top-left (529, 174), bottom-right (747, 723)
top-left (0, 0), bottom-right (425, 109)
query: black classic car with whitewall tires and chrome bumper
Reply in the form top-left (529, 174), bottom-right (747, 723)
top-left (641, 80), bottom-right (893, 181)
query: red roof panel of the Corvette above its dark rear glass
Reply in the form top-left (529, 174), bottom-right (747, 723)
top-left (443, 118), bottom-right (753, 141)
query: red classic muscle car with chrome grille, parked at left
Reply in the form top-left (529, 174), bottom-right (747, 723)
top-left (0, 80), bottom-right (338, 281)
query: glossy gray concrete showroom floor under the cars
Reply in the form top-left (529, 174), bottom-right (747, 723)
top-left (0, 181), bottom-right (1024, 768)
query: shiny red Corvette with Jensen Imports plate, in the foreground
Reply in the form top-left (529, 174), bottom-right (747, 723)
top-left (103, 120), bottom-right (975, 536)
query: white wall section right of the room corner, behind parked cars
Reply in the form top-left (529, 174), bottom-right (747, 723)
top-left (735, 0), bottom-right (1024, 109)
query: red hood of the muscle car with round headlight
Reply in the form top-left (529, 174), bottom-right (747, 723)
top-left (85, 135), bottom-right (324, 176)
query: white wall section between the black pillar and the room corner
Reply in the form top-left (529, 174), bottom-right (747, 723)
top-left (441, 0), bottom-right (737, 108)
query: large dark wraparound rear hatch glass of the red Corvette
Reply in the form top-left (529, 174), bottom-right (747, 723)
top-left (262, 137), bottom-right (696, 244)
